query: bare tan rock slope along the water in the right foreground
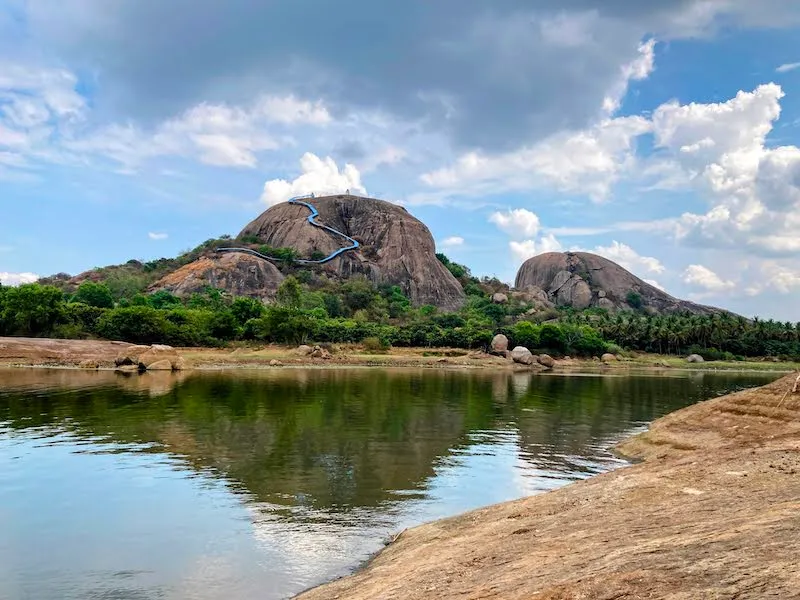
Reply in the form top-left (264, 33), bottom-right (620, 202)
top-left (299, 375), bottom-right (800, 600)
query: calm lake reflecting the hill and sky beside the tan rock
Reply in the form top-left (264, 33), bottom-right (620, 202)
top-left (0, 369), bottom-right (775, 600)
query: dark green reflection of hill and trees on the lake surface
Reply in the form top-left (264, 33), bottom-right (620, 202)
top-left (0, 369), bottom-right (776, 511)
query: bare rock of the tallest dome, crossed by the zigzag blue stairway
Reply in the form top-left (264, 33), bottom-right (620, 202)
top-left (234, 195), bottom-right (464, 310)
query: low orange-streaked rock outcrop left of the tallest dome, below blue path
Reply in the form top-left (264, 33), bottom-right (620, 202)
top-left (150, 252), bottom-right (283, 300)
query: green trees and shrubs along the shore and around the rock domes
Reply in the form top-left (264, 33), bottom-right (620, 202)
top-left (9, 252), bottom-right (800, 360)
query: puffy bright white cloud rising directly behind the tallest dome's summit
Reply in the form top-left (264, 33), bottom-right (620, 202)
top-left (261, 152), bottom-right (367, 206)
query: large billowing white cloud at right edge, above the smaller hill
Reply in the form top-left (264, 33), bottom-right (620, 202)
top-left (653, 83), bottom-right (800, 254)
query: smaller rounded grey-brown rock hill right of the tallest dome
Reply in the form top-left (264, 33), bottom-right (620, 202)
top-left (515, 252), bottom-right (721, 314)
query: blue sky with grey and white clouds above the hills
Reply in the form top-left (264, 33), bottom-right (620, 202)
top-left (0, 0), bottom-right (800, 321)
